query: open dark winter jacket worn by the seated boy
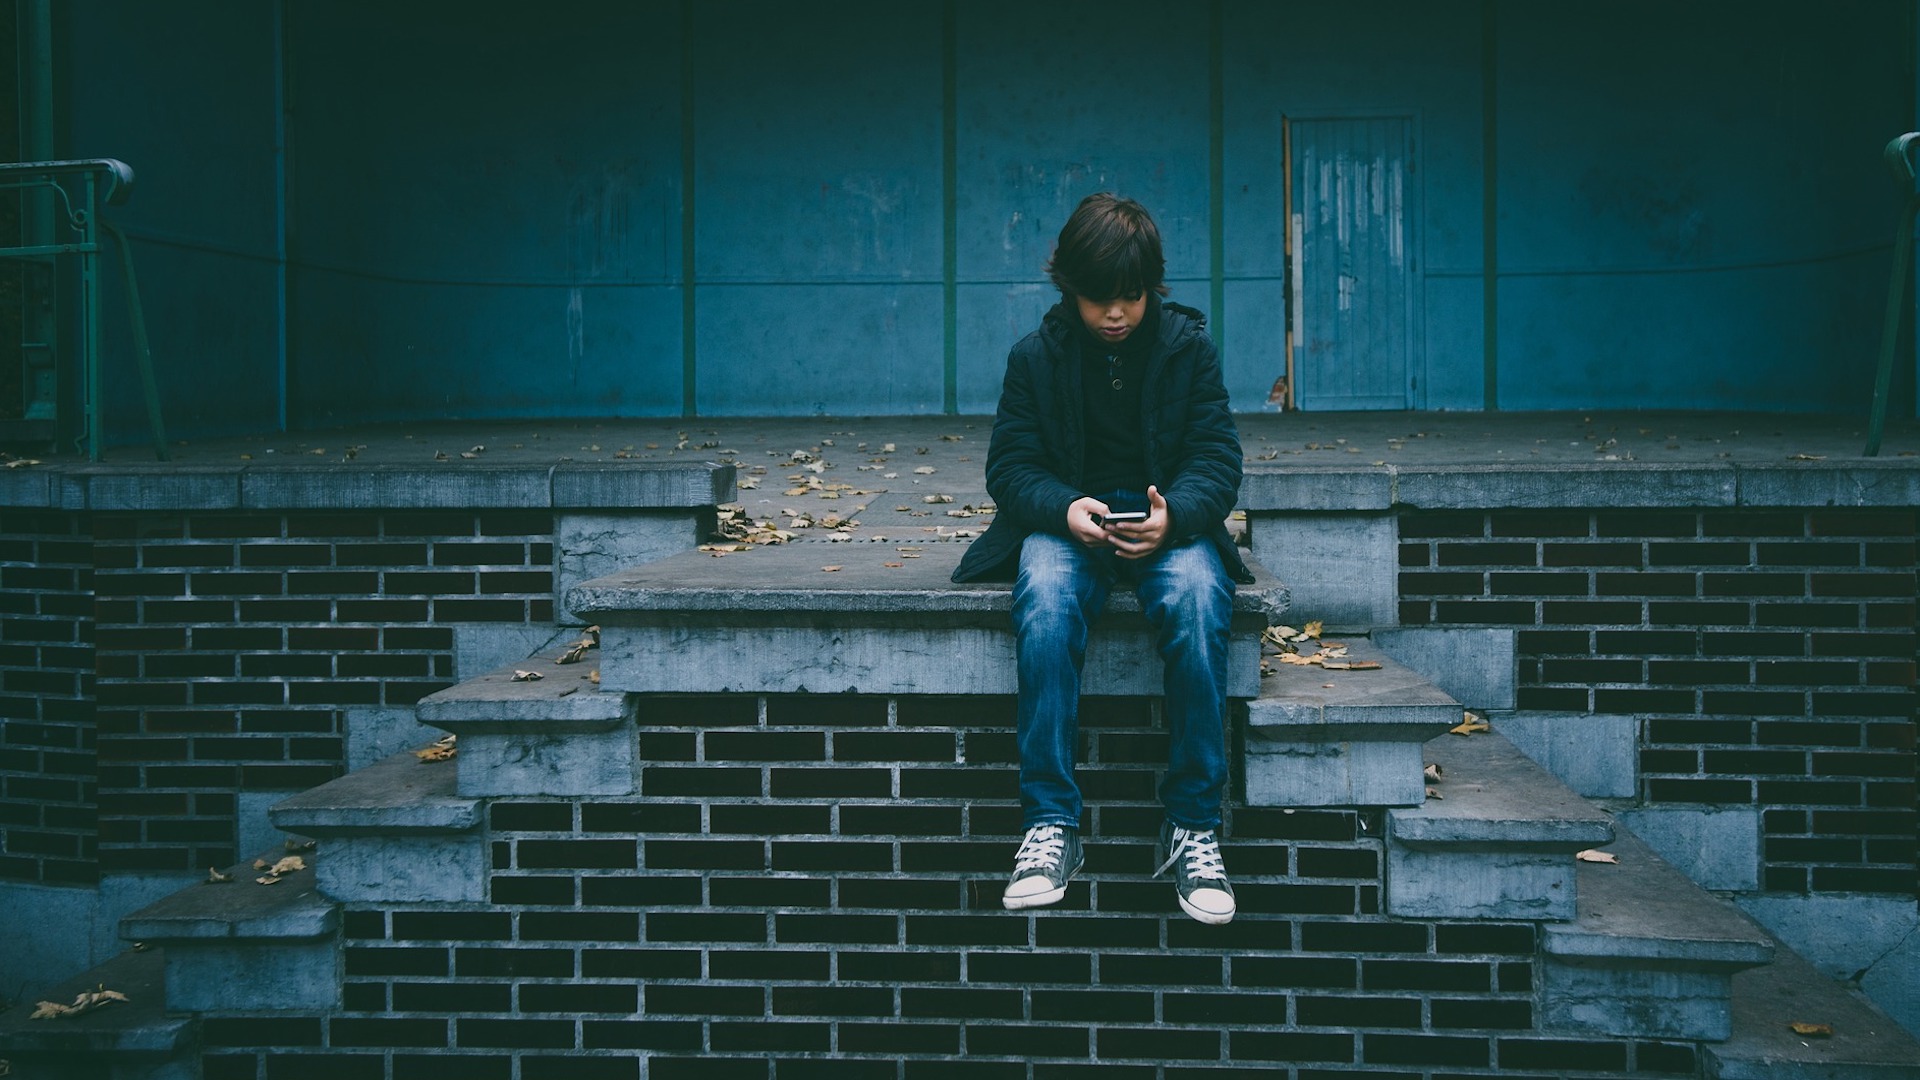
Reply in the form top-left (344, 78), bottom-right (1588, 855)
top-left (952, 294), bottom-right (1254, 584)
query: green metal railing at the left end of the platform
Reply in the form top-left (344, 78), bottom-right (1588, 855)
top-left (0, 158), bottom-right (167, 461)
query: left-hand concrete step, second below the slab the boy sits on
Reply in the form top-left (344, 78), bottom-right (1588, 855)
top-left (267, 751), bottom-right (488, 903)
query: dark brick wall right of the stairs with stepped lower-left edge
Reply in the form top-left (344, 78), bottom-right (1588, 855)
top-left (1400, 509), bottom-right (1916, 894)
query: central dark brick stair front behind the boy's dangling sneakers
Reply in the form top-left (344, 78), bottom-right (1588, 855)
top-left (191, 696), bottom-right (1697, 1080)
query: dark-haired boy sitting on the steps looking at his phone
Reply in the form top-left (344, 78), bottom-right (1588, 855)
top-left (954, 192), bottom-right (1252, 924)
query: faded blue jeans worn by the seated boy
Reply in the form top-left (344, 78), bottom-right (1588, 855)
top-left (1014, 518), bottom-right (1233, 828)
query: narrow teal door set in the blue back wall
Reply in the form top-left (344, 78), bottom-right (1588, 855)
top-left (1290, 117), bottom-right (1419, 411)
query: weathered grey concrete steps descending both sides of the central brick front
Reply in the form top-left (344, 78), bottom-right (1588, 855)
top-left (0, 544), bottom-right (1920, 1080)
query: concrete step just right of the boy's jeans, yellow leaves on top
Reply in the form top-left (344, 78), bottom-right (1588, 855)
top-left (1244, 638), bottom-right (1461, 807)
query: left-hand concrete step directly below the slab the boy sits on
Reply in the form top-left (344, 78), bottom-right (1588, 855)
top-left (415, 648), bottom-right (633, 798)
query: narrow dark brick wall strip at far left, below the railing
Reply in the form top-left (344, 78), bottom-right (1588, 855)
top-left (0, 509), bottom-right (98, 884)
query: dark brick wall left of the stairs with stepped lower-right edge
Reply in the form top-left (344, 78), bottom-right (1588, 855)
top-left (94, 511), bottom-right (553, 871)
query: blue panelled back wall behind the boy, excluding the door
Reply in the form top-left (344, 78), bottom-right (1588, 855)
top-left (65, 0), bottom-right (1914, 438)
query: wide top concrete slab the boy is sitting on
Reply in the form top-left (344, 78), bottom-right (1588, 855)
top-left (568, 542), bottom-right (1286, 699)
